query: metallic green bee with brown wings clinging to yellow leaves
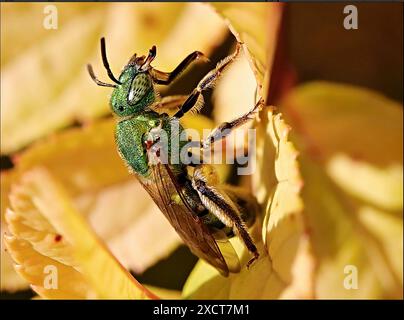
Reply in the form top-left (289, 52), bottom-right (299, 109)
top-left (87, 38), bottom-right (262, 276)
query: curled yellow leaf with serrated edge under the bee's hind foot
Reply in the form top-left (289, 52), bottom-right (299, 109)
top-left (183, 111), bottom-right (306, 299)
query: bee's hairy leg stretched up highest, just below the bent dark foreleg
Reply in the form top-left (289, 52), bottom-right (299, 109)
top-left (174, 43), bottom-right (241, 118)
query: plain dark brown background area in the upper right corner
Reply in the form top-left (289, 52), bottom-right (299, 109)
top-left (286, 2), bottom-right (403, 101)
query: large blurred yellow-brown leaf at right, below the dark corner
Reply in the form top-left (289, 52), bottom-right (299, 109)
top-left (281, 82), bottom-right (403, 298)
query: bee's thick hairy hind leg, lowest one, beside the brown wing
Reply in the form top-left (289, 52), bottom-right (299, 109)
top-left (192, 165), bottom-right (259, 267)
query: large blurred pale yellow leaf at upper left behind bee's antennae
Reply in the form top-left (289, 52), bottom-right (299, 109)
top-left (1, 3), bottom-right (226, 154)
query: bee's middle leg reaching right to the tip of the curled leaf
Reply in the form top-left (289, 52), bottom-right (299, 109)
top-left (201, 98), bottom-right (264, 148)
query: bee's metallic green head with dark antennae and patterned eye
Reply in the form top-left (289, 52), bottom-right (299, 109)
top-left (87, 38), bottom-right (156, 117)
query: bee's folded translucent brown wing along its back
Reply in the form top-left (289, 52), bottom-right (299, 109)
top-left (143, 163), bottom-right (240, 276)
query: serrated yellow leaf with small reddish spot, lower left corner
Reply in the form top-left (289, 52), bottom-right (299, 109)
top-left (5, 168), bottom-right (155, 299)
